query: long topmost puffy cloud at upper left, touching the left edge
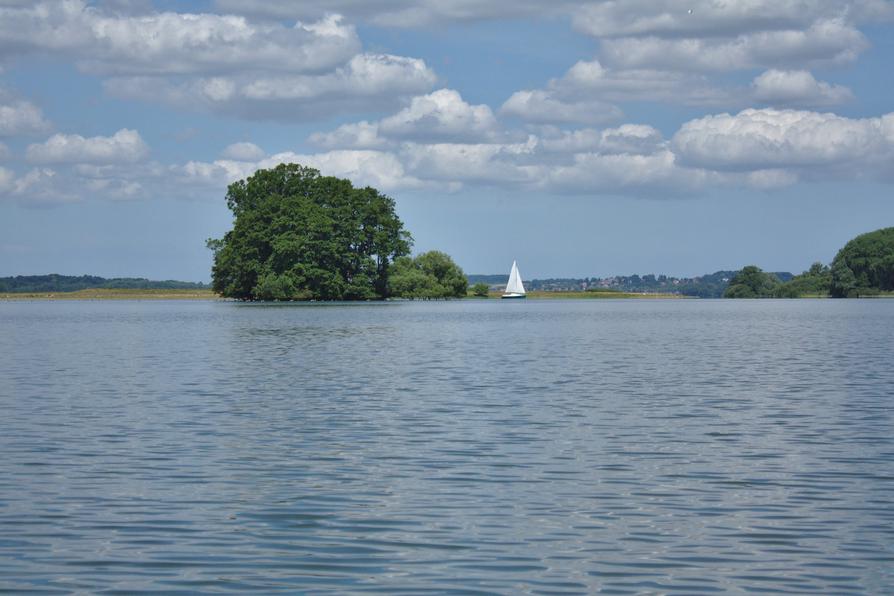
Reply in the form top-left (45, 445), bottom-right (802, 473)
top-left (0, 0), bottom-right (360, 75)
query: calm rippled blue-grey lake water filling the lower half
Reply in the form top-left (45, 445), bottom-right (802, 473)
top-left (0, 300), bottom-right (894, 594)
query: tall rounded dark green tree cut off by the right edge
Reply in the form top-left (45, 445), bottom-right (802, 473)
top-left (830, 228), bottom-right (894, 298)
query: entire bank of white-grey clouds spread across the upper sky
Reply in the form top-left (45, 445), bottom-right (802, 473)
top-left (0, 0), bottom-right (894, 204)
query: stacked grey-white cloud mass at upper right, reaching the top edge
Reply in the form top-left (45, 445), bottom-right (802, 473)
top-left (501, 0), bottom-right (894, 119)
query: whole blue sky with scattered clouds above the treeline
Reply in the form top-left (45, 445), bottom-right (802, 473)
top-left (0, 0), bottom-right (894, 281)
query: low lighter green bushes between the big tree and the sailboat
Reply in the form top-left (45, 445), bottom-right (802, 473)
top-left (388, 250), bottom-right (468, 300)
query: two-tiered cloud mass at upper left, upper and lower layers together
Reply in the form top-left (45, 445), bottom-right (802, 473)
top-left (0, 0), bottom-right (436, 121)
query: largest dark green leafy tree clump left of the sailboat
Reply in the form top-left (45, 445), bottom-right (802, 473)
top-left (208, 164), bottom-right (412, 300)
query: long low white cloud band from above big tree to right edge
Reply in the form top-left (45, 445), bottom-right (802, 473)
top-left (173, 109), bottom-right (894, 197)
